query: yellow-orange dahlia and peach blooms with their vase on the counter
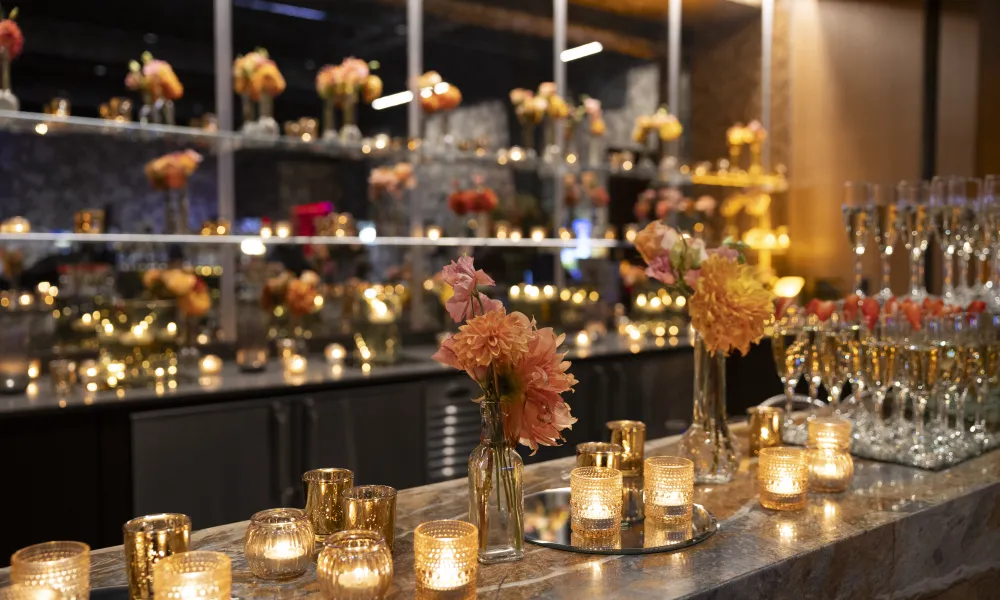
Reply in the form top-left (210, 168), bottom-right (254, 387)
top-left (635, 221), bottom-right (774, 483)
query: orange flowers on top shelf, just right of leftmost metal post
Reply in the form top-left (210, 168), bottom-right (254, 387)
top-left (233, 48), bottom-right (286, 136)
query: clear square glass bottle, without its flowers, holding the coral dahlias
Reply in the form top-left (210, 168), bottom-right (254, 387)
top-left (469, 399), bottom-right (524, 564)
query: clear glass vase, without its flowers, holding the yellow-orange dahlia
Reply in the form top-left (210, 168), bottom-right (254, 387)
top-left (680, 333), bottom-right (740, 483)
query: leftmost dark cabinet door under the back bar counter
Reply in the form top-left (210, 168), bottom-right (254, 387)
top-left (131, 400), bottom-right (294, 529)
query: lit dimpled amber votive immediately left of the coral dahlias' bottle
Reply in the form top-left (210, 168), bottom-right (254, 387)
top-left (413, 521), bottom-right (479, 591)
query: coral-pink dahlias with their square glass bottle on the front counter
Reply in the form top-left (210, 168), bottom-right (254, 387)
top-left (434, 256), bottom-right (577, 562)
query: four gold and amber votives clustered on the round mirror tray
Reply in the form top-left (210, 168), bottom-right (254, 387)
top-left (570, 421), bottom-right (694, 535)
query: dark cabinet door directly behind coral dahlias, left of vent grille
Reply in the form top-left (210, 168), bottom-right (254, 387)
top-left (303, 382), bottom-right (426, 489)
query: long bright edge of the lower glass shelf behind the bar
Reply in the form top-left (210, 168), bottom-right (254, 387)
top-left (0, 232), bottom-right (631, 249)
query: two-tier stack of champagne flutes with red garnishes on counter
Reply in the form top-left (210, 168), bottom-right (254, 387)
top-left (772, 176), bottom-right (1000, 469)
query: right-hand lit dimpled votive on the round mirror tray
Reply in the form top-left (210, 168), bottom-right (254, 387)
top-left (643, 456), bottom-right (694, 523)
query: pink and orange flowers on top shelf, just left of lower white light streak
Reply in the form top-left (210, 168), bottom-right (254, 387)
top-left (316, 56), bottom-right (382, 142)
